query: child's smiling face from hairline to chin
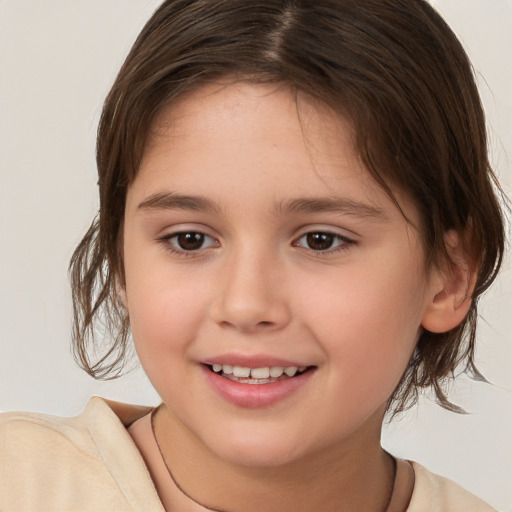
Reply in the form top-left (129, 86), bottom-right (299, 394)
top-left (124, 80), bottom-right (432, 465)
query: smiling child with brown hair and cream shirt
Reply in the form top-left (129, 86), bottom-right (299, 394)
top-left (0, 0), bottom-right (504, 512)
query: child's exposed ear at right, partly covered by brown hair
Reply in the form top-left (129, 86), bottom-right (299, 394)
top-left (421, 230), bottom-right (476, 333)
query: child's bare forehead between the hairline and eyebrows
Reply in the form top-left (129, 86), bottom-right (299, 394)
top-left (129, 82), bottom-right (420, 226)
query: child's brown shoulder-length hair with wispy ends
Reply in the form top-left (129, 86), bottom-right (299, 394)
top-left (70, 0), bottom-right (505, 413)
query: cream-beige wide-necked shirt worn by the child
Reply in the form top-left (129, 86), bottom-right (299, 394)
top-left (0, 397), bottom-right (496, 512)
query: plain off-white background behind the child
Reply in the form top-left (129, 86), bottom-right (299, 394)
top-left (0, 0), bottom-right (512, 512)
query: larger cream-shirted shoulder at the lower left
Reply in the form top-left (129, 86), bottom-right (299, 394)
top-left (0, 398), bottom-right (162, 511)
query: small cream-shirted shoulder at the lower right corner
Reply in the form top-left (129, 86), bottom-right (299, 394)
top-left (407, 462), bottom-right (496, 512)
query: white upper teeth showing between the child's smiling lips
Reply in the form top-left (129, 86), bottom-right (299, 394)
top-left (207, 364), bottom-right (313, 384)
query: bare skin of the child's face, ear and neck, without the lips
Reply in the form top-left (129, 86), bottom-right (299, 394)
top-left (123, 83), bottom-right (465, 512)
